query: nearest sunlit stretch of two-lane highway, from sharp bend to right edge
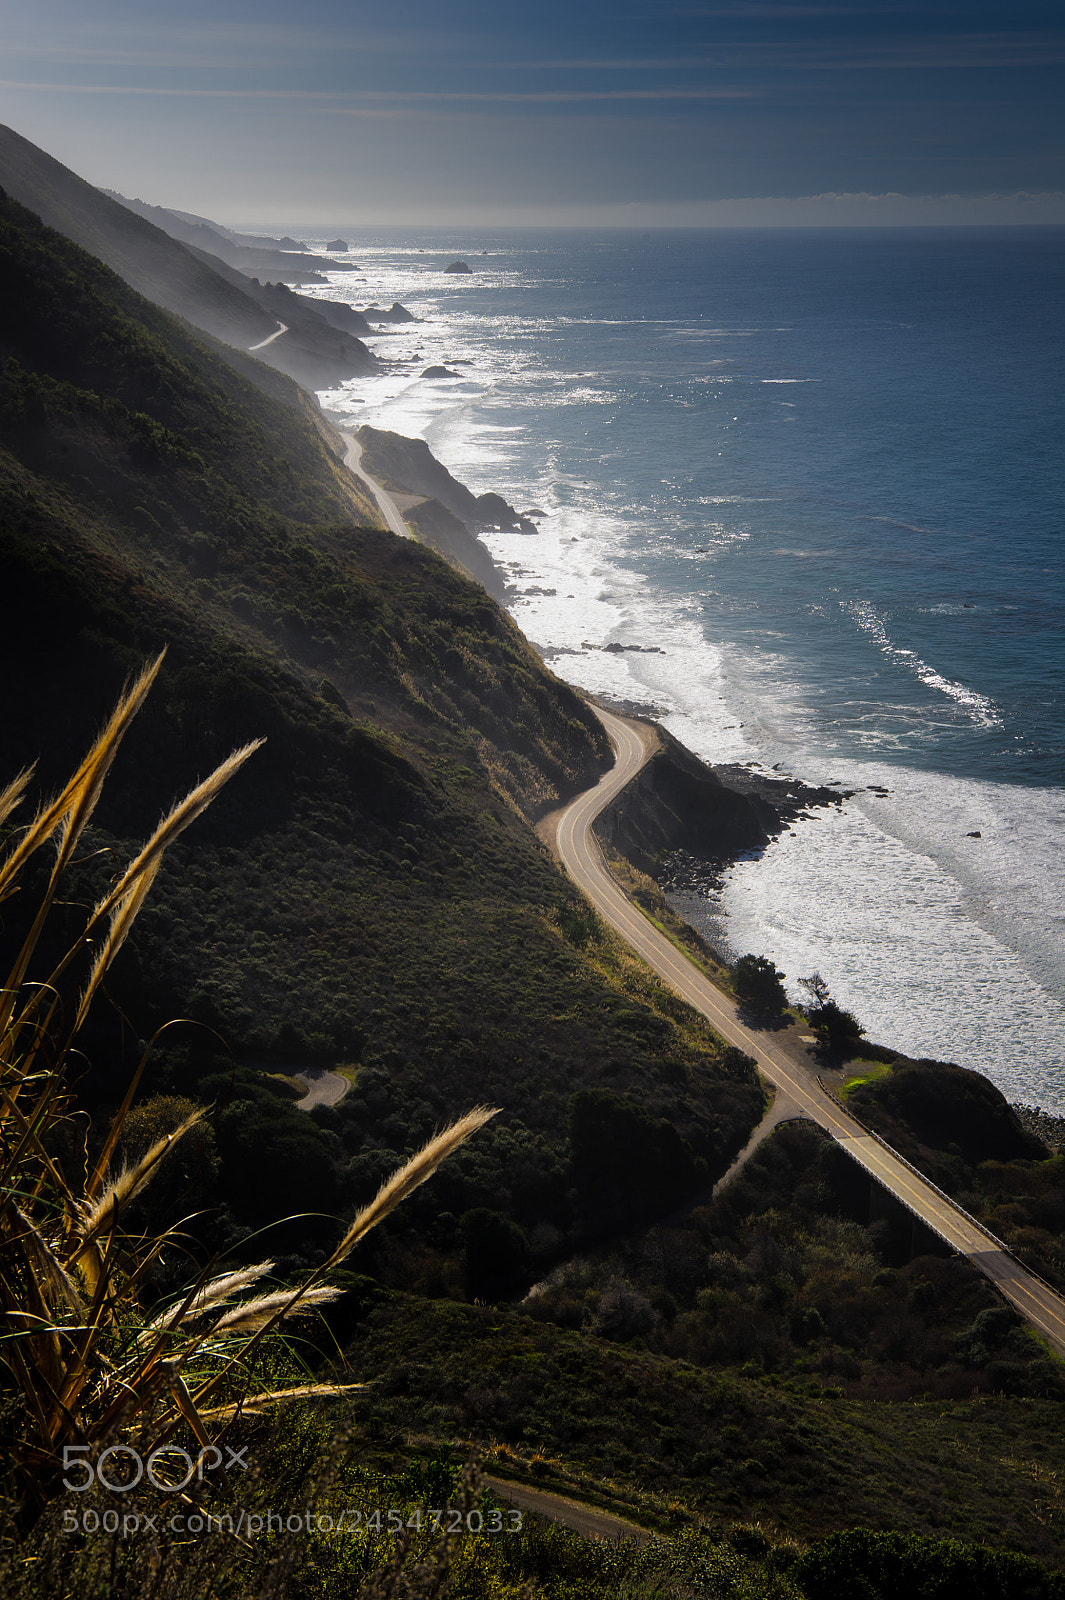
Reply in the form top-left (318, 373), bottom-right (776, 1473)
top-left (552, 706), bottom-right (1065, 1357)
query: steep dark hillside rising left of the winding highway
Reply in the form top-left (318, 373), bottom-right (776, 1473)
top-left (0, 184), bottom-right (760, 1260)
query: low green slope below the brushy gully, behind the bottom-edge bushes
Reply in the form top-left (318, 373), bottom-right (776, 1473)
top-left (341, 1283), bottom-right (1065, 1568)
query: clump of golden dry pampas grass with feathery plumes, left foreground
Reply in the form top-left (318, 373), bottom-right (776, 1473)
top-left (0, 656), bottom-right (494, 1509)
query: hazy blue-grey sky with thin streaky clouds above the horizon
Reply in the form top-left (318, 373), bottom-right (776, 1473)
top-left (0, 0), bottom-right (1065, 229)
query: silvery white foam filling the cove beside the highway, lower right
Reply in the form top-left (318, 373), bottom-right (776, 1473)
top-left (723, 793), bottom-right (1065, 1109)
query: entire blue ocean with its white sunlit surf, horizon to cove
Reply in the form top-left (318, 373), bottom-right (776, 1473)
top-left (292, 229), bottom-right (1065, 1114)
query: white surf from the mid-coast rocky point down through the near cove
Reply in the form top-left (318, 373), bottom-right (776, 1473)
top-left (479, 492), bottom-right (1065, 1112)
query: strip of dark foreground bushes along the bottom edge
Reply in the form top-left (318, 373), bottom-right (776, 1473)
top-left (8, 1413), bottom-right (1065, 1600)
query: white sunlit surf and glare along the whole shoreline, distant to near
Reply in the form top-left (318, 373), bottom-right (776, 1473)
top-left (300, 232), bottom-right (1065, 1112)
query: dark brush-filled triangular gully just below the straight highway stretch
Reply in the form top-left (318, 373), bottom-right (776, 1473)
top-left (526, 1123), bottom-right (1063, 1400)
